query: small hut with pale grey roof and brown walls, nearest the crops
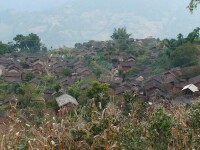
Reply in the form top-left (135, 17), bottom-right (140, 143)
top-left (56, 94), bottom-right (78, 116)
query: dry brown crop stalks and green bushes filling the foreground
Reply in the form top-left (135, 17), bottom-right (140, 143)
top-left (1, 93), bottom-right (200, 150)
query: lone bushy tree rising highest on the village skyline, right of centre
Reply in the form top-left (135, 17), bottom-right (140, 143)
top-left (111, 28), bottom-right (131, 40)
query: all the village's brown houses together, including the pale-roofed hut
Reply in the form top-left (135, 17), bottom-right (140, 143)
top-left (0, 38), bottom-right (200, 114)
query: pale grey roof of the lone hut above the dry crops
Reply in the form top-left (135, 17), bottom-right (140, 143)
top-left (56, 94), bottom-right (78, 107)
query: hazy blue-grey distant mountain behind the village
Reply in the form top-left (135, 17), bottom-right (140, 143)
top-left (0, 0), bottom-right (200, 47)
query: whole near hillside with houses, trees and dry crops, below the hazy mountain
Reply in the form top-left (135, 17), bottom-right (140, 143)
top-left (0, 28), bottom-right (200, 150)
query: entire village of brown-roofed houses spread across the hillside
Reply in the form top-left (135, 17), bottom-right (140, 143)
top-left (0, 37), bottom-right (200, 115)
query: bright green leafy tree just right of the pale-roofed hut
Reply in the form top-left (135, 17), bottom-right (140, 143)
top-left (87, 82), bottom-right (110, 109)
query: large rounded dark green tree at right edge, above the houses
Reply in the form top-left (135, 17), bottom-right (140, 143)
top-left (171, 44), bottom-right (199, 67)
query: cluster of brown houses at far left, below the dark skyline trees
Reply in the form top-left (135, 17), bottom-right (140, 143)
top-left (0, 53), bottom-right (49, 82)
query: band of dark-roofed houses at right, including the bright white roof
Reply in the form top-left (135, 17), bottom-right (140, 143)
top-left (106, 68), bottom-right (200, 101)
